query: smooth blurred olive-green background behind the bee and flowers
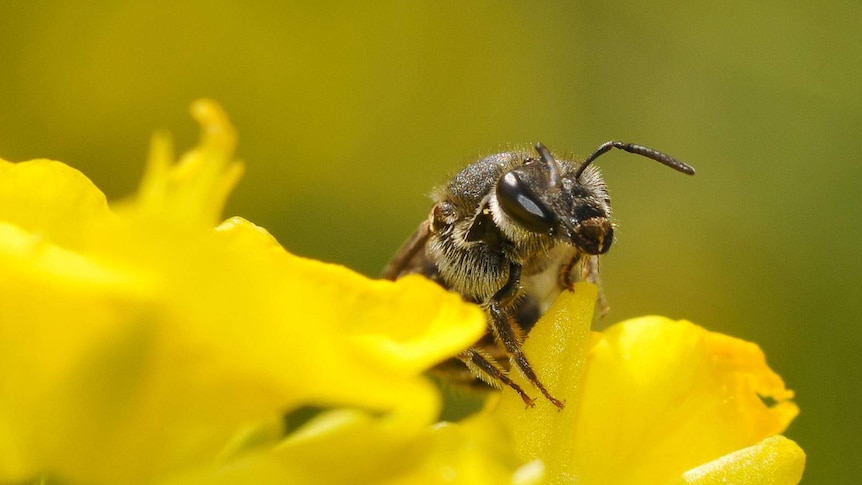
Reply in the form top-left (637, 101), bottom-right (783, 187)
top-left (0, 0), bottom-right (862, 484)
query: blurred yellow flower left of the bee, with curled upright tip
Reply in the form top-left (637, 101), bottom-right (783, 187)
top-left (0, 101), bottom-right (485, 483)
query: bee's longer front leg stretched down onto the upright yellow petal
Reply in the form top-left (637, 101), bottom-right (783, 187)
top-left (488, 263), bottom-right (565, 410)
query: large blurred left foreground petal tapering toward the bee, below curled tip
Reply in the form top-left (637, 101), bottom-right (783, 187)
top-left (0, 194), bottom-right (484, 483)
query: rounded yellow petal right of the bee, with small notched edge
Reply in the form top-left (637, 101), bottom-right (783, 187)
top-left (571, 317), bottom-right (798, 483)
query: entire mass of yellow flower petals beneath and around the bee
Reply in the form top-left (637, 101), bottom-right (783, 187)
top-left (0, 101), bottom-right (805, 485)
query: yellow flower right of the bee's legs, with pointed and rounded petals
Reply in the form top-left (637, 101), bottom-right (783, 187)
top-left (496, 284), bottom-right (805, 485)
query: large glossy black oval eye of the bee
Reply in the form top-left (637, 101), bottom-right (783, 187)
top-left (497, 172), bottom-right (557, 233)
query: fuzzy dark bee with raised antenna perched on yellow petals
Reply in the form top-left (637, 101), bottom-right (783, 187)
top-left (383, 141), bottom-right (694, 410)
